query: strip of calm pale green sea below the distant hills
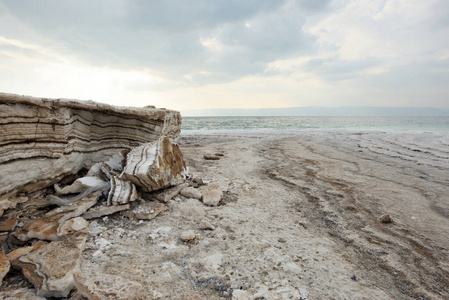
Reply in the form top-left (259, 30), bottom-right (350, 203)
top-left (182, 117), bottom-right (449, 133)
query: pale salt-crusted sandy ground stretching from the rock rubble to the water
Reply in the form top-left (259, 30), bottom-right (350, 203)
top-left (75, 131), bottom-right (449, 299)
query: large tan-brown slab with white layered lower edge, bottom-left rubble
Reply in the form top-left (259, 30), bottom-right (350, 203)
top-left (17, 234), bottom-right (86, 297)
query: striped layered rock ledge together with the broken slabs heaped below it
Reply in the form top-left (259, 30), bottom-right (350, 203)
top-left (0, 94), bottom-right (222, 299)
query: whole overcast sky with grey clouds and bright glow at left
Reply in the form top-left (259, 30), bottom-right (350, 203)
top-left (0, 0), bottom-right (449, 110)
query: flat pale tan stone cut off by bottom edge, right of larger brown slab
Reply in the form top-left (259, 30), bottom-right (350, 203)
top-left (74, 273), bottom-right (143, 300)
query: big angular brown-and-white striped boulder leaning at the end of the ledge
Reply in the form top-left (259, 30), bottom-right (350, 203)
top-left (120, 136), bottom-right (186, 192)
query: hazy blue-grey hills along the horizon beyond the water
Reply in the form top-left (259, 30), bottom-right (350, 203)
top-left (181, 106), bottom-right (449, 117)
